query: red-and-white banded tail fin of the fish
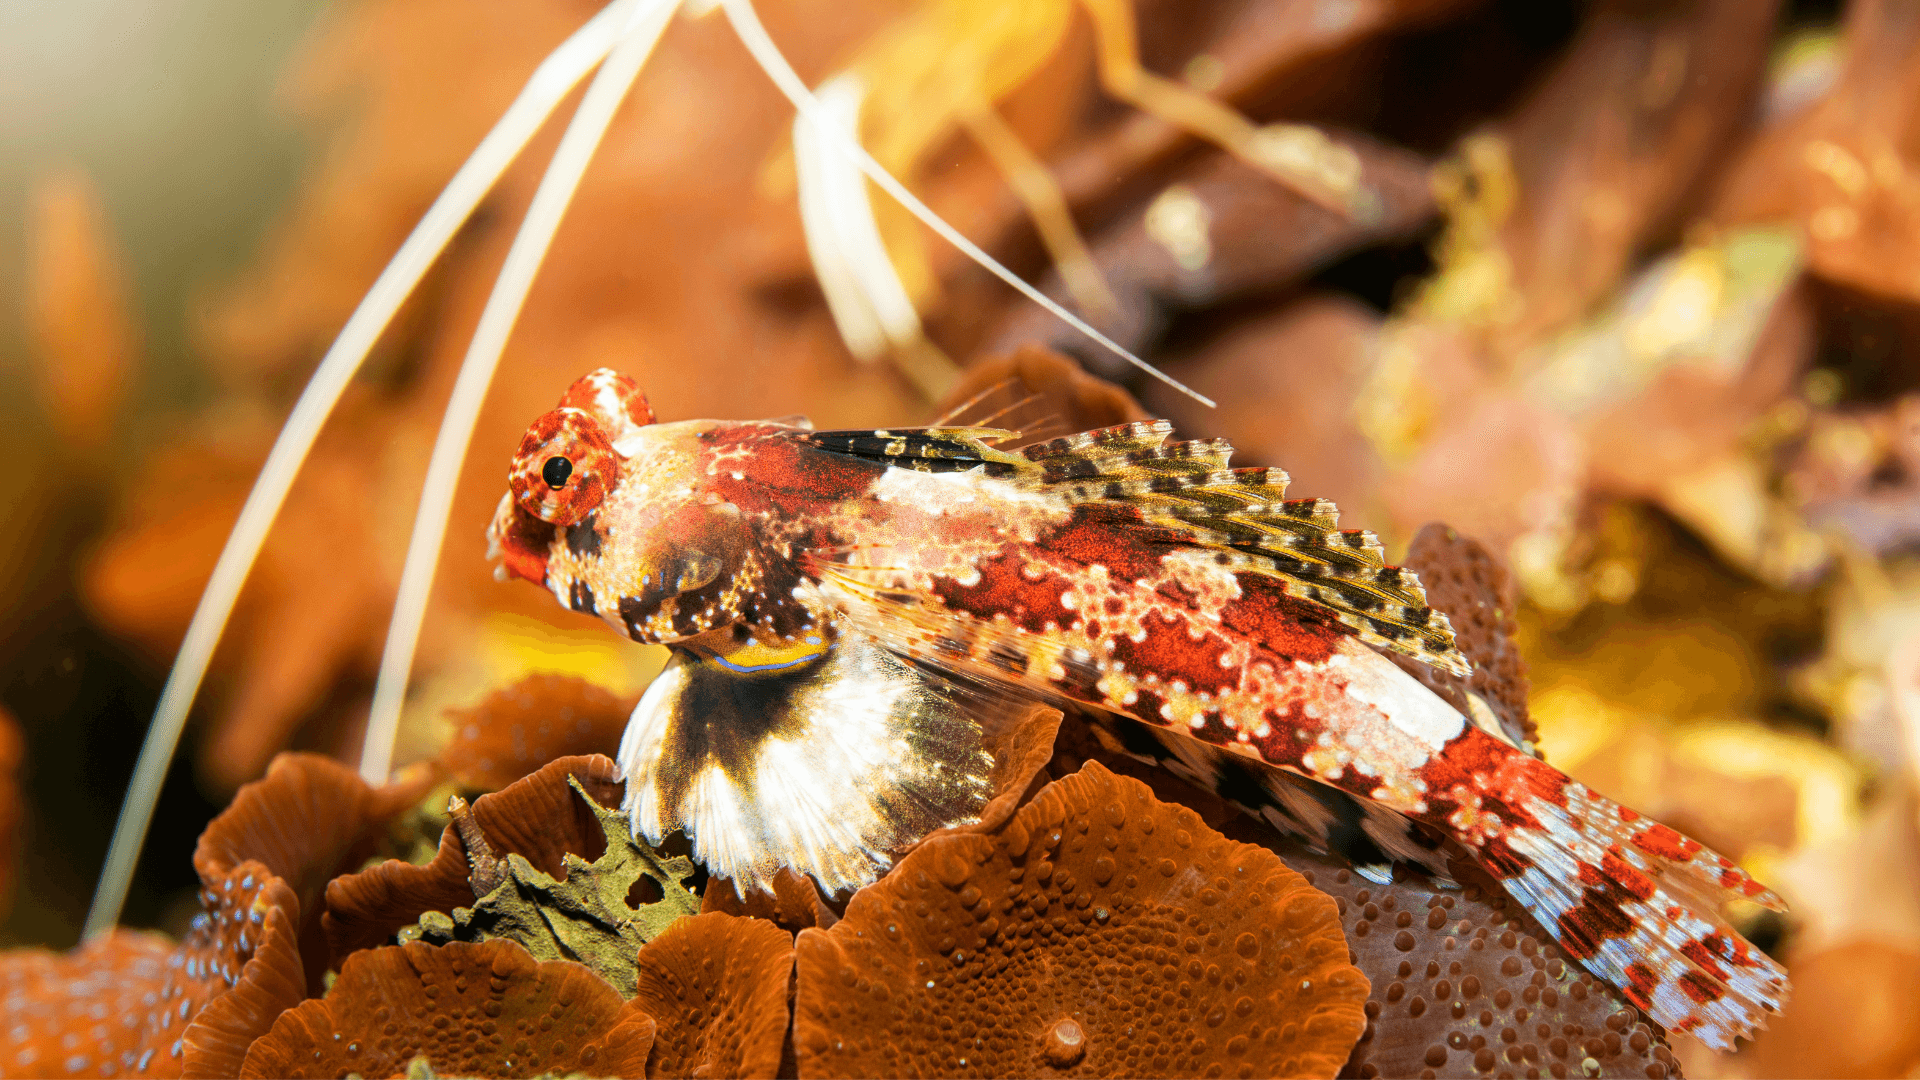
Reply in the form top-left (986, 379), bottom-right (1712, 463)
top-left (1501, 763), bottom-right (1788, 1051)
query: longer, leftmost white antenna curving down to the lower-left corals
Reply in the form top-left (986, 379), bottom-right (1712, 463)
top-left (84, 12), bottom-right (618, 938)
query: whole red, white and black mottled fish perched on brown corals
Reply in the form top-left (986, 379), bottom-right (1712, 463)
top-left (490, 371), bottom-right (1786, 1049)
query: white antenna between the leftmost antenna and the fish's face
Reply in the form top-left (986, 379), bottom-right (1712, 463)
top-left (361, 0), bottom-right (680, 784)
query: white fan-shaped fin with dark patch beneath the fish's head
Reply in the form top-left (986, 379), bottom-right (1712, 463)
top-left (620, 634), bottom-right (993, 892)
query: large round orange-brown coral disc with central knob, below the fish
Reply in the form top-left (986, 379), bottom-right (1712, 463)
top-left (795, 763), bottom-right (1367, 1078)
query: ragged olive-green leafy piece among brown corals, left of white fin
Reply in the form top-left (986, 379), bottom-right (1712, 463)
top-left (399, 776), bottom-right (701, 997)
